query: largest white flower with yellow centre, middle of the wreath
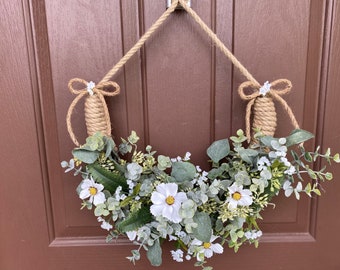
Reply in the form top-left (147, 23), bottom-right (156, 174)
top-left (150, 183), bottom-right (188, 223)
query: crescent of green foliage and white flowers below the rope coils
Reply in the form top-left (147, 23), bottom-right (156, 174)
top-left (61, 130), bottom-right (340, 270)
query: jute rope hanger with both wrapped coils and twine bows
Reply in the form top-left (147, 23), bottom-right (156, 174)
top-left (66, 0), bottom-right (299, 146)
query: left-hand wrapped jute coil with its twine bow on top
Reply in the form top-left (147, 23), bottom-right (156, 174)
top-left (66, 78), bottom-right (120, 146)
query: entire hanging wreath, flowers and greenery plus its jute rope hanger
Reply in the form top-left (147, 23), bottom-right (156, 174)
top-left (61, 0), bottom-right (340, 270)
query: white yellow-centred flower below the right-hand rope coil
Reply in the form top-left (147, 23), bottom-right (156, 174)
top-left (227, 183), bottom-right (253, 209)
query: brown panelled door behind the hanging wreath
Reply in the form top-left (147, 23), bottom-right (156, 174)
top-left (0, 0), bottom-right (340, 270)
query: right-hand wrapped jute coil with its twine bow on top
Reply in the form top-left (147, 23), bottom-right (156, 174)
top-left (238, 79), bottom-right (299, 142)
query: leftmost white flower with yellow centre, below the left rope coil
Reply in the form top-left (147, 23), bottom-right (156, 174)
top-left (79, 177), bottom-right (106, 205)
